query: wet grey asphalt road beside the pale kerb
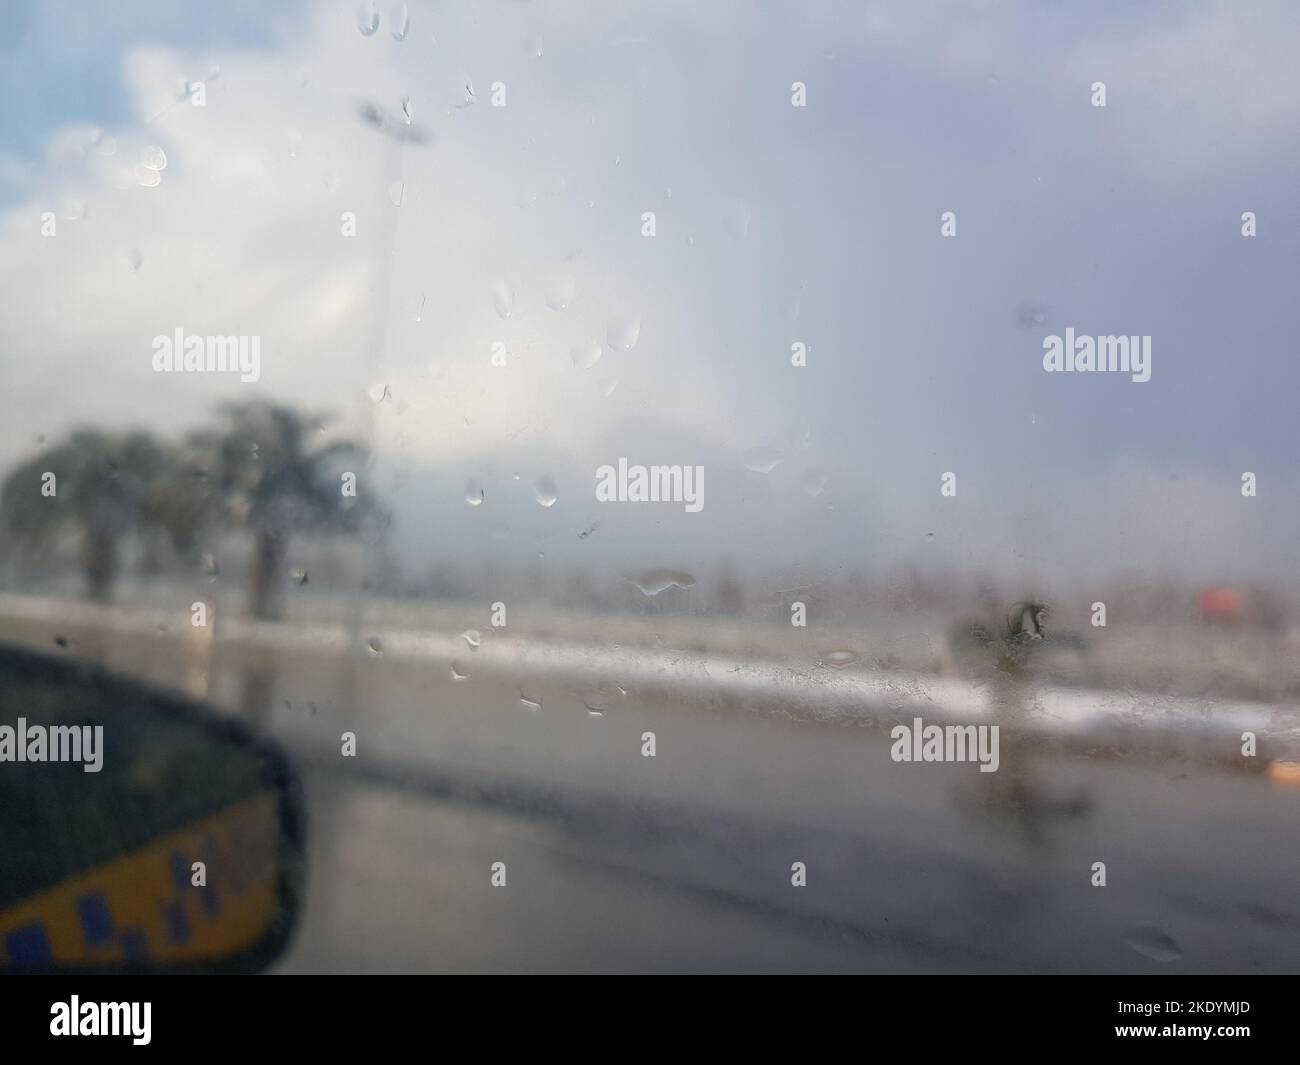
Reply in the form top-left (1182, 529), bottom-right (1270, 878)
top-left (261, 662), bottom-right (1300, 973)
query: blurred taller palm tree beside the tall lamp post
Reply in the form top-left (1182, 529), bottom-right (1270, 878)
top-left (186, 402), bottom-right (378, 618)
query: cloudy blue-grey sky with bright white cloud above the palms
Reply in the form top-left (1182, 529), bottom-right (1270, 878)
top-left (0, 0), bottom-right (1300, 585)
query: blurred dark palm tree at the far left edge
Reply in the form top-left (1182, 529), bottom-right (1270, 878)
top-left (0, 429), bottom-right (174, 602)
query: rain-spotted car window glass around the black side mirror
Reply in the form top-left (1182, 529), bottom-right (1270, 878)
top-left (0, 0), bottom-right (1300, 973)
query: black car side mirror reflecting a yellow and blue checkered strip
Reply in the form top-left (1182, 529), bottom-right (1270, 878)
top-left (0, 649), bottom-right (304, 973)
